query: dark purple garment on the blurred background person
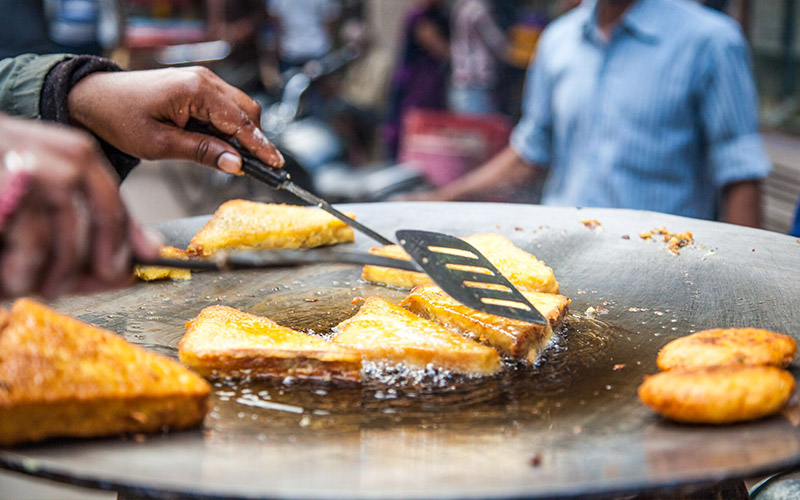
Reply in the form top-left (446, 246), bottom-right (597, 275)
top-left (384, 6), bottom-right (449, 155)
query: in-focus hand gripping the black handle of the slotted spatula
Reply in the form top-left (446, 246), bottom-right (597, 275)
top-left (67, 67), bottom-right (284, 173)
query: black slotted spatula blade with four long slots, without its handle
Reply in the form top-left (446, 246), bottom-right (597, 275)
top-left (395, 229), bottom-right (548, 326)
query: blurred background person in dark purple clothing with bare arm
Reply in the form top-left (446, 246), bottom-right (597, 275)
top-left (383, 0), bottom-right (450, 157)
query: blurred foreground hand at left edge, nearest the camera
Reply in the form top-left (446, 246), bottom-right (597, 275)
top-left (0, 115), bottom-right (159, 297)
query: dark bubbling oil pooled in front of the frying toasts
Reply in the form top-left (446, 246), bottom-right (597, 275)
top-left (206, 316), bottom-right (627, 434)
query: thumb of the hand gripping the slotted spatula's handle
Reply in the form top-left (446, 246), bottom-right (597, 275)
top-left (158, 125), bottom-right (242, 174)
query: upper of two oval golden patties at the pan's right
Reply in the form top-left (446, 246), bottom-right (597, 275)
top-left (656, 328), bottom-right (797, 371)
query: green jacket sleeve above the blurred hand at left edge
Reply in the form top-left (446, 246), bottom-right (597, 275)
top-left (0, 54), bottom-right (73, 119)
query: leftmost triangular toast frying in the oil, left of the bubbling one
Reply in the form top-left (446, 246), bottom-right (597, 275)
top-left (178, 306), bottom-right (361, 381)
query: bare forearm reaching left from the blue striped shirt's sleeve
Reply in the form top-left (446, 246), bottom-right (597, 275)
top-left (437, 147), bottom-right (536, 201)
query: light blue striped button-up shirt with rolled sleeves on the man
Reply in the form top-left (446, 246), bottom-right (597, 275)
top-left (511, 0), bottom-right (771, 219)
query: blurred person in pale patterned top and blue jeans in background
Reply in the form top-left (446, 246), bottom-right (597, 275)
top-left (447, 0), bottom-right (508, 115)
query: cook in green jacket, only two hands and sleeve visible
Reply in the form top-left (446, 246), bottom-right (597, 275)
top-left (0, 54), bottom-right (283, 298)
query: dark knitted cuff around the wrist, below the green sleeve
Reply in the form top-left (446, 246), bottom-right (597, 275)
top-left (39, 56), bottom-right (139, 179)
